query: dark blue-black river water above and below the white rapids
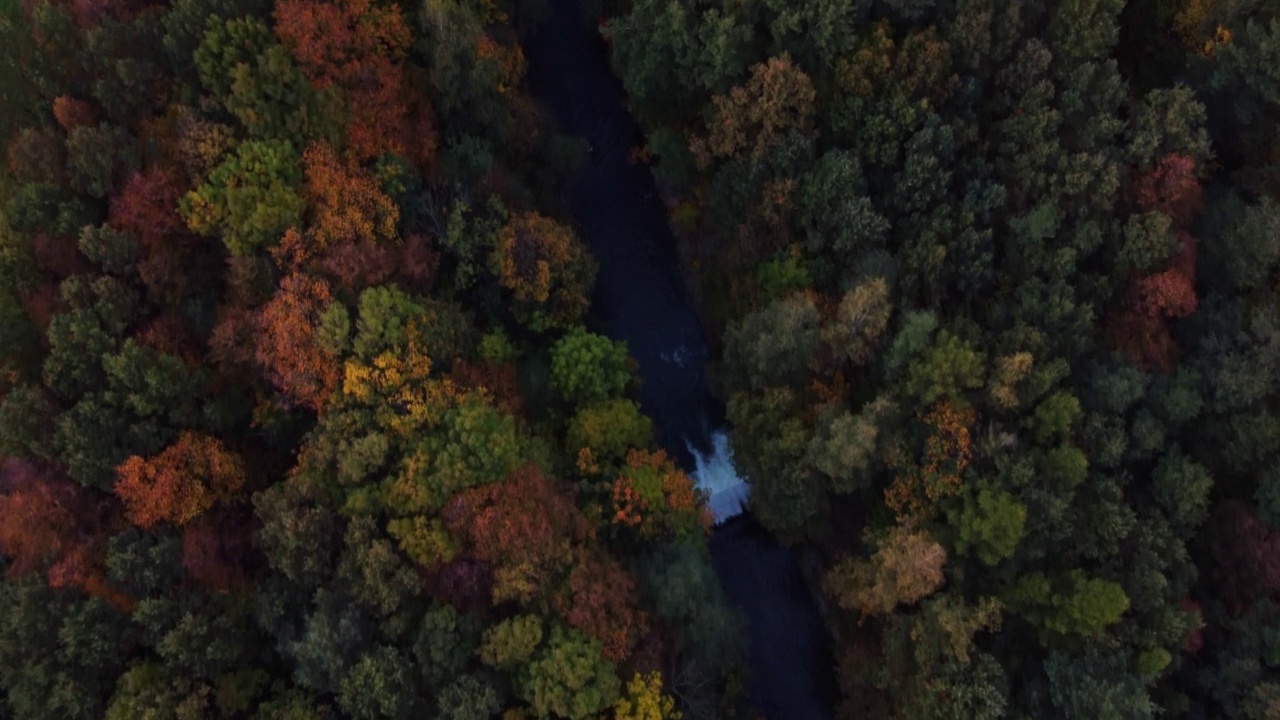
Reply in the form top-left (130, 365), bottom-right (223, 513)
top-left (525, 0), bottom-right (835, 720)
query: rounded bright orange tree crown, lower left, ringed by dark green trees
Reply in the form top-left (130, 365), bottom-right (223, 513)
top-left (115, 432), bottom-right (244, 529)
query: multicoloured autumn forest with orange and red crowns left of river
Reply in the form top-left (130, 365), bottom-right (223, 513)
top-left (0, 0), bottom-right (742, 720)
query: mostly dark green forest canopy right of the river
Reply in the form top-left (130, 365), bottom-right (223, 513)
top-left (603, 0), bottom-right (1280, 719)
